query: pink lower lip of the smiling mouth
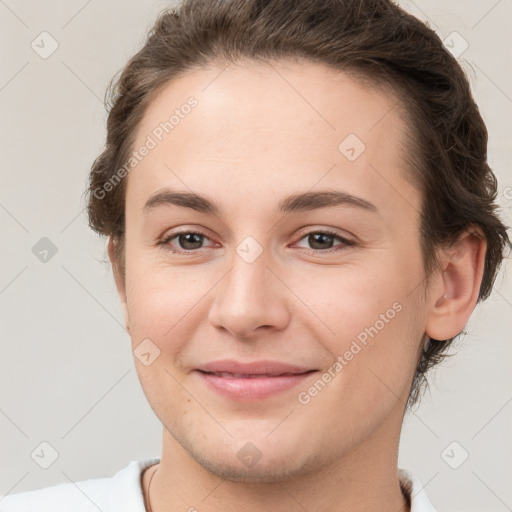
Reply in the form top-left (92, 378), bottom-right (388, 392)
top-left (198, 372), bottom-right (316, 400)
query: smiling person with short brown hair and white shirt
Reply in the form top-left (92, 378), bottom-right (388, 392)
top-left (0, 0), bottom-right (508, 512)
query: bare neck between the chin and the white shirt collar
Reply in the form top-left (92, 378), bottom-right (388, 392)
top-left (144, 412), bottom-right (409, 512)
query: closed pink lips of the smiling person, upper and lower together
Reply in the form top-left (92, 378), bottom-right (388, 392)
top-left (196, 360), bottom-right (316, 400)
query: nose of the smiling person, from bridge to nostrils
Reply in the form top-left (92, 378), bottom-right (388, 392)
top-left (208, 244), bottom-right (293, 340)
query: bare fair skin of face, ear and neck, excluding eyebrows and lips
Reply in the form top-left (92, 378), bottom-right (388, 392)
top-left (109, 61), bottom-right (485, 512)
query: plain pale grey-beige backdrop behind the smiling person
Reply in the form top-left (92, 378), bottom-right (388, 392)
top-left (0, 0), bottom-right (512, 512)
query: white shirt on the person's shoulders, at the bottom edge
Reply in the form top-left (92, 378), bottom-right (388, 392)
top-left (0, 457), bottom-right (436, 512)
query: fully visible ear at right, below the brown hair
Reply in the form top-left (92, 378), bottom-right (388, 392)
top-left (425, 226), bottom-right (487, 340)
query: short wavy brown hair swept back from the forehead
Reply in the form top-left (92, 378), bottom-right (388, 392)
top-left (87, 0), bottom-right (510, 406)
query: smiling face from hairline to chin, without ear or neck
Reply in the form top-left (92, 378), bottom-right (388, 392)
top-left (115, 61), bottom-right (426, 481)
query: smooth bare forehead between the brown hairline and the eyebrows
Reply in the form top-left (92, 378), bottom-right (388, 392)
top-left (128, 61), bottom-right (415, 222)
